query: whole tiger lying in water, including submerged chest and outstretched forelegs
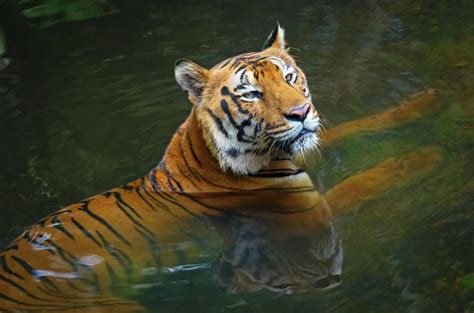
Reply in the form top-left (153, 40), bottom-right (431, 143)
top-left (0, 24), bottom-right (442, 312)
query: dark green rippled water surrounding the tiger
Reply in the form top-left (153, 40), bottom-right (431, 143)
top-left (0, 1), bottom-right (474, 312)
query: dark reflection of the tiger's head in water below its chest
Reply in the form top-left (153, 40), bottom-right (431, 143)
top-left (214, 210), bottom-right (343, 294)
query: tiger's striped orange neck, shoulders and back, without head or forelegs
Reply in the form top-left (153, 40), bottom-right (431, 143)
top-left (0, 114), bottom-right (321, 311)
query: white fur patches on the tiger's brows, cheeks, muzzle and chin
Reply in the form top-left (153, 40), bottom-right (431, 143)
top-left (205, 57), bottom-right (320, 175)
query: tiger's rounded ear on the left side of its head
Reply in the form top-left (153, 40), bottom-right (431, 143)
top-left (174, 59), bottom-right (209, 101)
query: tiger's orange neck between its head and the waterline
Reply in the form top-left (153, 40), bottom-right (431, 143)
top-left (147, 109), bottom-right (313, 193)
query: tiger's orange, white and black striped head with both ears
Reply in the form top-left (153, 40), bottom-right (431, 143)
top-left (175, 23), bottom-right (320, 175)
